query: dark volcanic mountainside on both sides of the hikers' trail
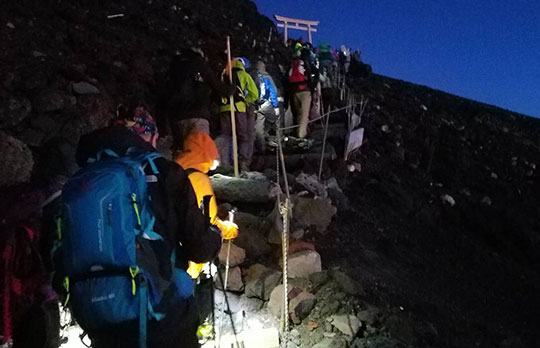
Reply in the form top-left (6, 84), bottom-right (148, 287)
top-left (0, 0), bottom-right (540, 348)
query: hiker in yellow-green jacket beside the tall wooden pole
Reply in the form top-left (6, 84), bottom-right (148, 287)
top-left (219, 57), bottom-right (259, 171)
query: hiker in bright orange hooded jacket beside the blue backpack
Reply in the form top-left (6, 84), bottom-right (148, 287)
top-left (175, 132), bottom-right (238, 279)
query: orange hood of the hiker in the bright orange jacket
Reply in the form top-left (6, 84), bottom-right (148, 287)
top-left (176, 133), bottom-right (219, 173)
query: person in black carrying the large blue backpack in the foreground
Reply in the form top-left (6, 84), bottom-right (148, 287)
top-left (60, 106), bottom-right (221, 348)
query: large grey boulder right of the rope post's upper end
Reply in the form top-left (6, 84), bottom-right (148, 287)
top-left (292, 196), bottom-right (337, 233)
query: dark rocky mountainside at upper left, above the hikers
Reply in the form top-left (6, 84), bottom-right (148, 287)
top-left (0, 0), bottom-right (283, 183)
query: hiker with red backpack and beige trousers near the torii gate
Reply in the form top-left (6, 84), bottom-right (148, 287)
top-left (289, 48), bottom-right (312, 139)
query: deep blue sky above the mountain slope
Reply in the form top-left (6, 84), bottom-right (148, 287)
top-left (255, 0), bottom-right (540, 117)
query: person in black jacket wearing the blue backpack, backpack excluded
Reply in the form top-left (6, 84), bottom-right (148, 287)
top-left (76, 107), bottom-right (222, 348)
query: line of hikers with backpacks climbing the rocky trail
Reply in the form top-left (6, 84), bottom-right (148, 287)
top-left (2, 37), bottom-right (359, 348)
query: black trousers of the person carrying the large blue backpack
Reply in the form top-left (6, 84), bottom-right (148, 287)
top-left (88, 297), bottom-right (199, 348)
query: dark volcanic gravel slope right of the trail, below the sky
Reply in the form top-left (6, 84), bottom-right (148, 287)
top-left (318, 76), bottom-right (540, 347)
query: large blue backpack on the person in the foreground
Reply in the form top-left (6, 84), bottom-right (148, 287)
top-left (59, 150), bottom-right (193, 347)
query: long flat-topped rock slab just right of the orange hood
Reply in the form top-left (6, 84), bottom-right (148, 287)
top-left (210, 174), bottom-right (279, 203)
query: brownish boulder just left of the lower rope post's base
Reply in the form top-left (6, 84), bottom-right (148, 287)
top-left (245, 264), bottom-right (281, 301)
